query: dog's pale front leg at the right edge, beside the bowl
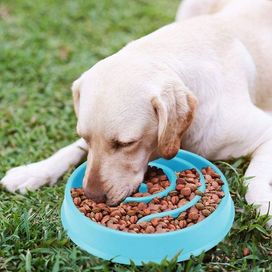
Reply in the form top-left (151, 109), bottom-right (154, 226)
top-left (245, 138), bottom-right (272, 225)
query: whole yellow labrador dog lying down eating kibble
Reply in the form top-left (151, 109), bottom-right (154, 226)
top-left (1, 0), bottom-right (272, 224)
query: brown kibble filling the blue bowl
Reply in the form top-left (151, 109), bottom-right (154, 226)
top-left (71, 167), bottom-right (224, 233)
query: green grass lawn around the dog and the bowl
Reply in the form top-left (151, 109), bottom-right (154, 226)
top-left (0, 0), bottom-right (272, 272)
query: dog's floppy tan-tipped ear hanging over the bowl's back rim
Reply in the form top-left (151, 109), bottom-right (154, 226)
top-left (151, 83), bottom-right (197, 159)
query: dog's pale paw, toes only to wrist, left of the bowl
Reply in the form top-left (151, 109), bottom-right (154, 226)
top-left (0, 162), bottom-right (55, 194)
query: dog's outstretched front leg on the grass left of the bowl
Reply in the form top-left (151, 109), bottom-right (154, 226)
top-left (0, 139), bottom-right (88, 194)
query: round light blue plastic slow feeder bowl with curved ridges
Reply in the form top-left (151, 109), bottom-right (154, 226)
top-left (61, 150), bottom-right (234, 265)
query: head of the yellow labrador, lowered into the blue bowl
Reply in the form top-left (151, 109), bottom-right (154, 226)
top-left (72, 58), bottom-right (196, 205)
